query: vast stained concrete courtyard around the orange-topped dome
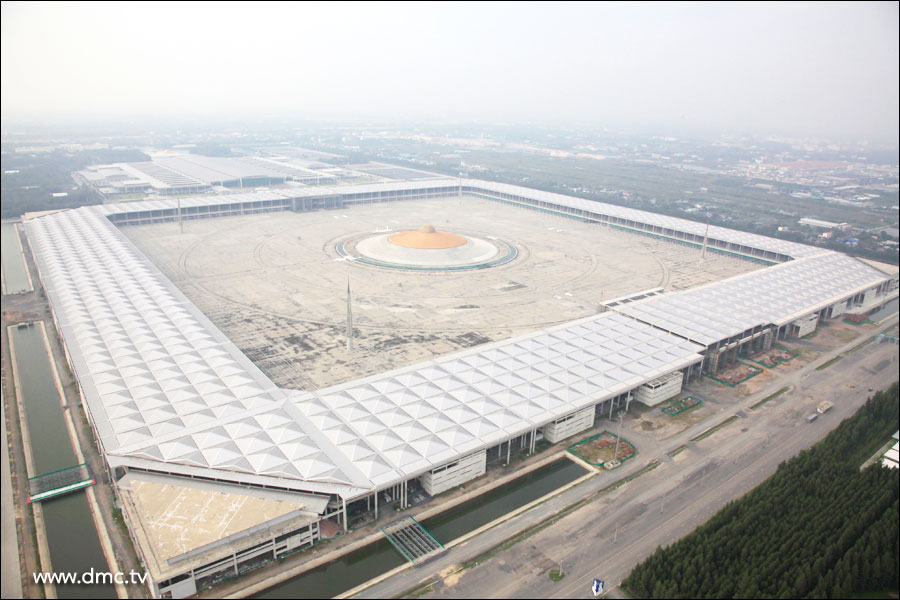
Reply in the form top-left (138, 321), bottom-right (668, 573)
top-left (122, 197), bottom-right (761, 390)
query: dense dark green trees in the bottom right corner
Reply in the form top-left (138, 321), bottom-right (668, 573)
top-left (623, 383), bottom-right (900, 598)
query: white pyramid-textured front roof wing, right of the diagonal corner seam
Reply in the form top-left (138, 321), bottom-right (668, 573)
top-left (295, 313), bottom-right (702, 487)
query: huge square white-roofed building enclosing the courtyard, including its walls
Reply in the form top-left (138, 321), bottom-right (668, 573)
top-left (25, 179), bottom-right (897, 596)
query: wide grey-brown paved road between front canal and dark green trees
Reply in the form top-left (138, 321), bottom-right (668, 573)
top-left (359, 317), bottom-right (898, 598)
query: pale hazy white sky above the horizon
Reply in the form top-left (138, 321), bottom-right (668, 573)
top-left (2, 2), bottom-right (900, 144)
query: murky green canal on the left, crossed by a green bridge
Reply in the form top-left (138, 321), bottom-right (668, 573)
top-left (8, 324), bottom-right (116, 598)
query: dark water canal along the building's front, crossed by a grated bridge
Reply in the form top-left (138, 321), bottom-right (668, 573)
top-left (254, 458), bottom-right (587, 598)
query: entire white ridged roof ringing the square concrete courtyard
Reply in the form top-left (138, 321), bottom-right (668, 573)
top-left (25, 180), bottom-right (885, 498)
